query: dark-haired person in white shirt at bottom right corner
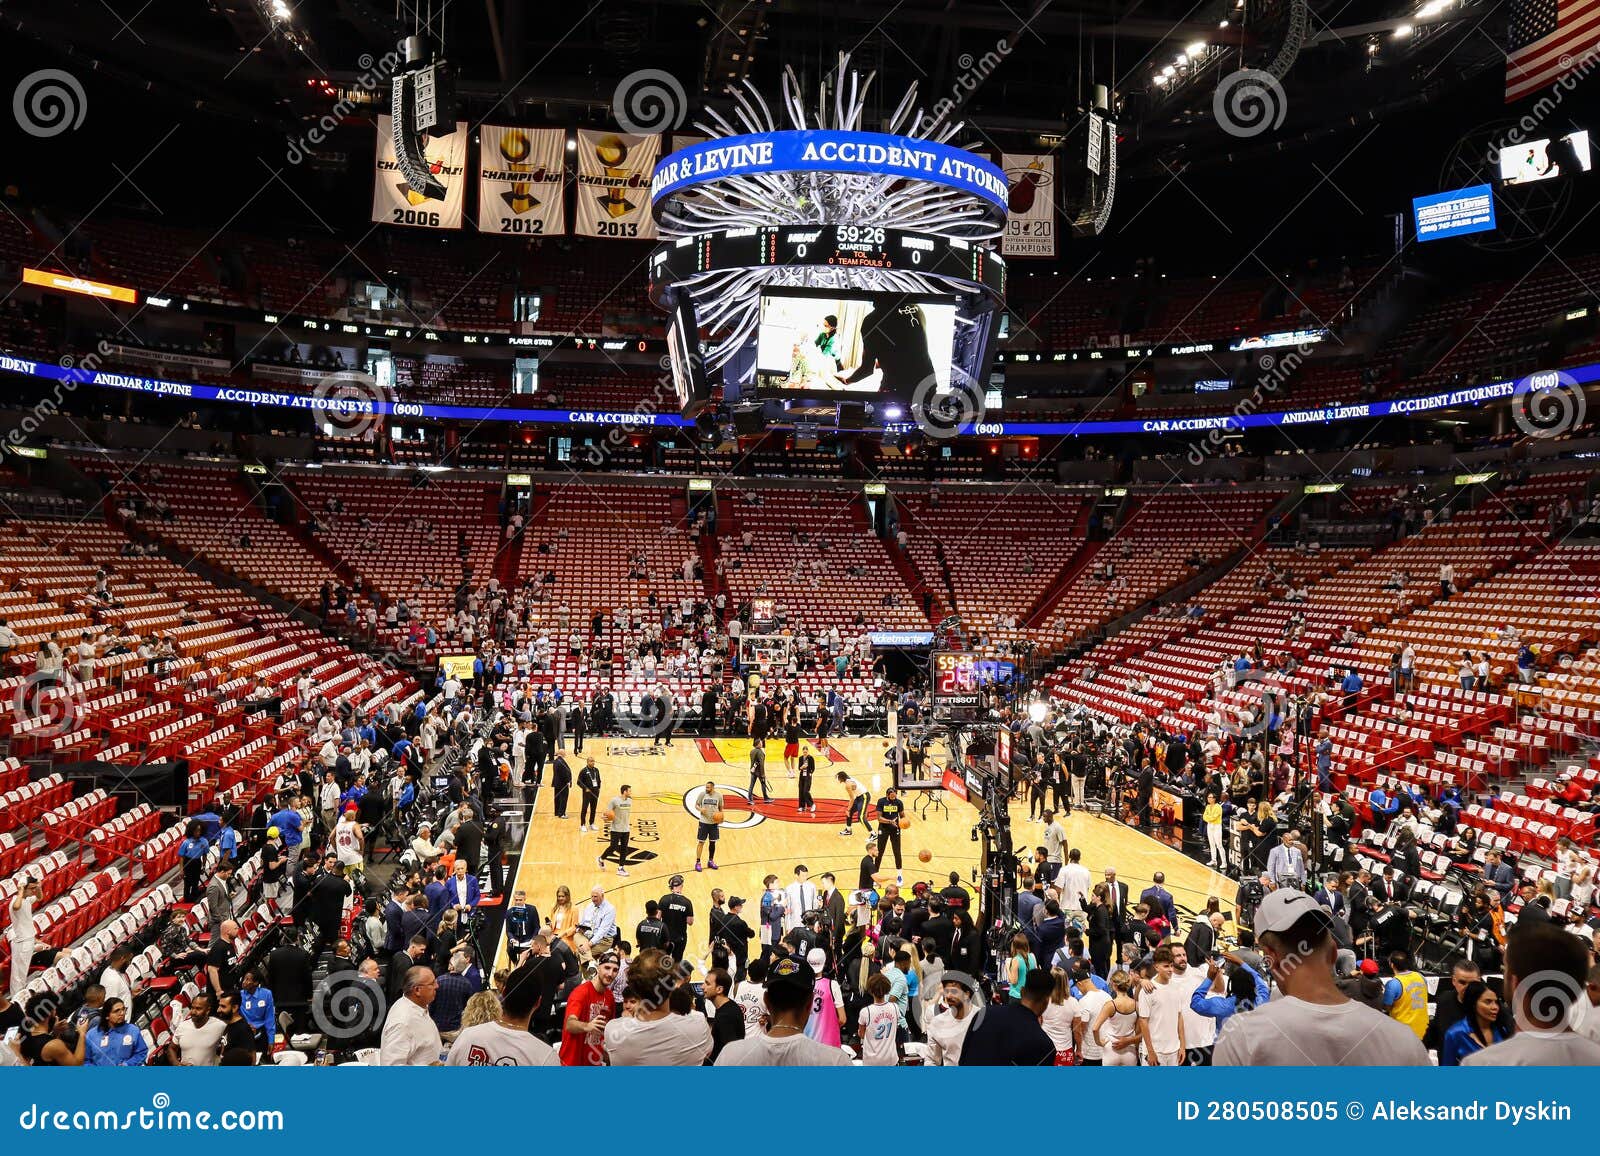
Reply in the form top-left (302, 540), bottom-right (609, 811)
top-left (1461, 924), bottom-right (1600, 1068)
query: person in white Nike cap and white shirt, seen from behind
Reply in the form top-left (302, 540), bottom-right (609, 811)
top-left (1211, 887), bottom-right (1429, 1068)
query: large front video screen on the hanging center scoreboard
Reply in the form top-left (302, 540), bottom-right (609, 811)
top-left (755, 290), bottom-right (955, 397)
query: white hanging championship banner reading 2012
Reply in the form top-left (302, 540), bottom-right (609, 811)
top-left (478, 125), bottom-right (566, 237)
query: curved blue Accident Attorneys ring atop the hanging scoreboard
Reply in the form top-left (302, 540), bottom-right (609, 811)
top-left (650, 130), bottom-right (1006, 216)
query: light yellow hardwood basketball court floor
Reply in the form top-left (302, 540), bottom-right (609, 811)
top-left (501, 737), bottom-right (1235, 962)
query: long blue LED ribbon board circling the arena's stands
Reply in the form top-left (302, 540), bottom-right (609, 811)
top-left (0, 351), bottom-right (1600, 437)
